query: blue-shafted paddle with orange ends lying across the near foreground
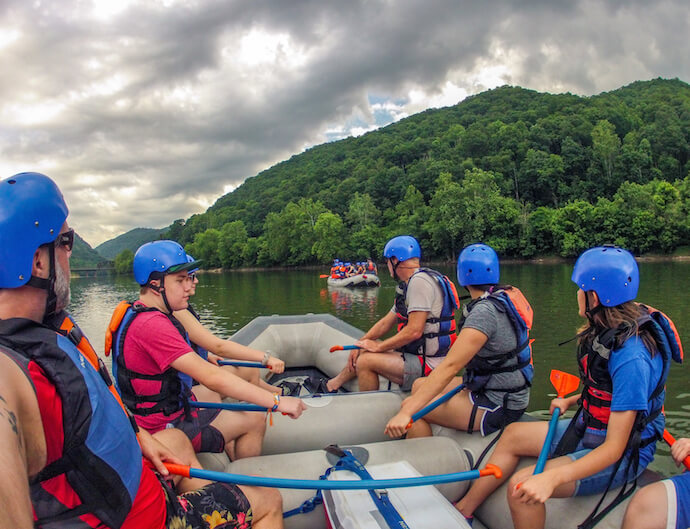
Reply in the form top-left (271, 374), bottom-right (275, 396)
top-left (163, 462), bottom-right (502, 490)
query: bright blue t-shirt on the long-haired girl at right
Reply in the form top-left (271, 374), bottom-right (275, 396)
top-left (592, 336), bottom-right (665, 468)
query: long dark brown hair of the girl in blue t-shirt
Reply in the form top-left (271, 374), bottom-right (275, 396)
top-left (578, 292), bottom-right (657, 356)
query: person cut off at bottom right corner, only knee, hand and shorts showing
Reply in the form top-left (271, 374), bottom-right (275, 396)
top-left (621, 438), bottom-right (690, 529)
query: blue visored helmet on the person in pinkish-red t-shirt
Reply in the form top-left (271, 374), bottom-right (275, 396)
top-left (132, 240), bottom-right (201, 286)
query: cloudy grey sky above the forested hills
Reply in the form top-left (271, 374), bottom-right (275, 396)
top-left (0, 0), bottom-right (690, 246)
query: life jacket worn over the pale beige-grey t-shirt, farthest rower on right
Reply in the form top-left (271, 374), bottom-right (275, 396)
top-left (395, 268), bottom-right (460, 363)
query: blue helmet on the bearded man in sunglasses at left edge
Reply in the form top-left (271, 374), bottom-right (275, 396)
top-left (0, 173), bottom-right (69, 288)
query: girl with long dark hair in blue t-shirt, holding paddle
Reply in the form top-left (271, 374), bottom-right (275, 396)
top-left (456, 246), bottom-right (682, 529)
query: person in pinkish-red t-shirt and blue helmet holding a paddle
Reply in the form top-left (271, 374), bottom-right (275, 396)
top-left (106, 240), bottom-right (305, 458)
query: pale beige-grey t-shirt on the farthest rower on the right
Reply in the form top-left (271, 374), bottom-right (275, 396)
top-left (391, 273), bottom-right (444, 369)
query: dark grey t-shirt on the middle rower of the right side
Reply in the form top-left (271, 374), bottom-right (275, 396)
top-left (463, 301), bottom-right (529, 410)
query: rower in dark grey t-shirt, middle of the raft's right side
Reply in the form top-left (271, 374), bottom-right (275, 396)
top-left (386, 244), bottom-right (534, 438)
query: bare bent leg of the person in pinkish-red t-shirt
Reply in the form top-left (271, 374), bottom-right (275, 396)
top-left (211, 410), bottom-right (266, 459)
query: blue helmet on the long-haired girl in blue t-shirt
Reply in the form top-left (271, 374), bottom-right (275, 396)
top-left (571, 246), bottom-right (640, 307)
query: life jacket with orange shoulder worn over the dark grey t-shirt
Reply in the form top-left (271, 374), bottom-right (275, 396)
top-left (460, 286), bottom-right (534, 393)
